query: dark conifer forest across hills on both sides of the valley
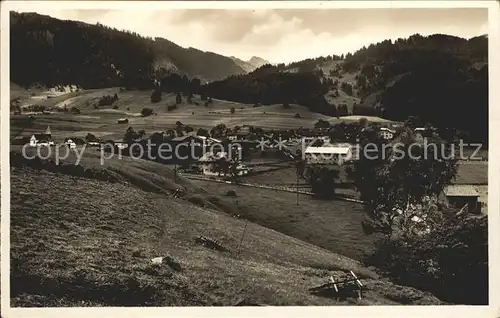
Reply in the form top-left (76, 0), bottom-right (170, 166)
top-left (10, 12), bottom-right (488, 143)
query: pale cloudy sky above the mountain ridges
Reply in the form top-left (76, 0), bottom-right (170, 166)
top-left (15, 8), bottom-right (488, 63)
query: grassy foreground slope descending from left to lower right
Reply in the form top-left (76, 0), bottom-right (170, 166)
top-left (11, 167), bottom-right (440, 306)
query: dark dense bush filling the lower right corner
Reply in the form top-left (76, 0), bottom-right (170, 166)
top-left (366, 215), bottom-right (488, 305)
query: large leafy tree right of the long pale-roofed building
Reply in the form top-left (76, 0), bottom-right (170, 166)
top-left (352, 128), bottom-right (457, 236)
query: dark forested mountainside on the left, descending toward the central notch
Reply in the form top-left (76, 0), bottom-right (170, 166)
top-left (10, 12), bottom-right (245, 88)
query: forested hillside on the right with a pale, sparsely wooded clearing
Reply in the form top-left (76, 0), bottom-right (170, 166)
top-left (201, 34), bottom-right (488, 142)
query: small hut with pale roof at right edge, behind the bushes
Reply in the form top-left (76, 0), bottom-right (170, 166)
top-left (444, 185), bottom-right (481, 214)
